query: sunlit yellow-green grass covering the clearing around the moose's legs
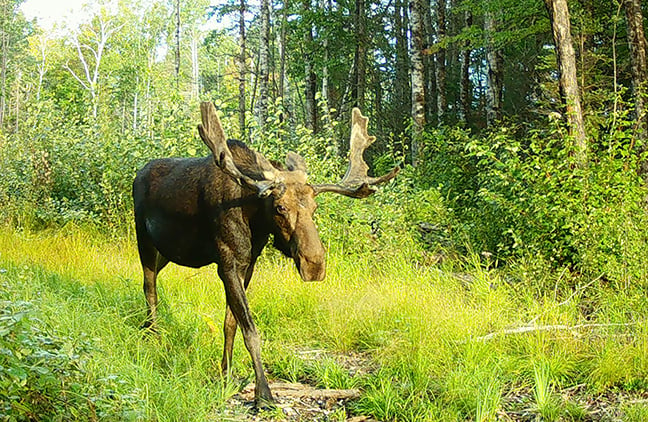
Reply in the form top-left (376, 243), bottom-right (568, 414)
top-left (0, 228), bottom-right (648, 421)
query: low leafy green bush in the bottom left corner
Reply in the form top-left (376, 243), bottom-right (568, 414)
top-left (0, 301), bottom-right (140, 420)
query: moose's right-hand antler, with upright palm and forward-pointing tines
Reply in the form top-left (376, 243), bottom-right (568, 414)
top-left (313, 108), bottom-right (400, 198)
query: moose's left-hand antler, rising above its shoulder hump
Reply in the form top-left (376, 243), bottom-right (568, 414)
top-left (198, 102), bottom-right (279, 196)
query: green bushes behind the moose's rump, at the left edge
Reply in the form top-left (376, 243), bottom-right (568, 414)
top-left (0, 101), bottom-right (200, 233)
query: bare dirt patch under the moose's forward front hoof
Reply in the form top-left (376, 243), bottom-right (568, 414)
top-left (224, 382), bottom-right (374, 422)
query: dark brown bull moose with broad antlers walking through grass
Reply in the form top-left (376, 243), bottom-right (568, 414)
top-left (133, 102), bottom-right (400, 407)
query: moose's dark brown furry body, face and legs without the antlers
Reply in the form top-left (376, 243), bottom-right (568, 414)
top-left (133, 141), bottom-right (325, 402)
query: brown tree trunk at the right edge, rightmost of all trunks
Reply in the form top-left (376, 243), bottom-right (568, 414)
top-left (623, 0), bottom-right (648, 145)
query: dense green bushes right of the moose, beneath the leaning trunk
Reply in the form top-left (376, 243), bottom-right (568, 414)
top-left (417, 118), bottom-right (648, 280)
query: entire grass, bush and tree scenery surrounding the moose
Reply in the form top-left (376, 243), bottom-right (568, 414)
top-left (0, 0), bottom-right (648, 422)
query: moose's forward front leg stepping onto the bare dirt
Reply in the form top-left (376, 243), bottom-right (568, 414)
top-left (218, 267), bottom-right (274, 407)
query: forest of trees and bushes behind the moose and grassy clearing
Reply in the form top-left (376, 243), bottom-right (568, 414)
top-left (0, 0), bottom-right (648, 420)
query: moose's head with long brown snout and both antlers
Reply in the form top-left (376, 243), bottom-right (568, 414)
top-left (198, 103), bottom-right (400, 281)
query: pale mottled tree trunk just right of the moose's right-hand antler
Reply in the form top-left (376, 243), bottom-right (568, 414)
top-left (410, 0), bottom-right (426, 166)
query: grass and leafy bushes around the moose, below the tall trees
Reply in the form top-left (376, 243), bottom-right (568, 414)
top-left (0, 109), bottom-right (648, 421)
